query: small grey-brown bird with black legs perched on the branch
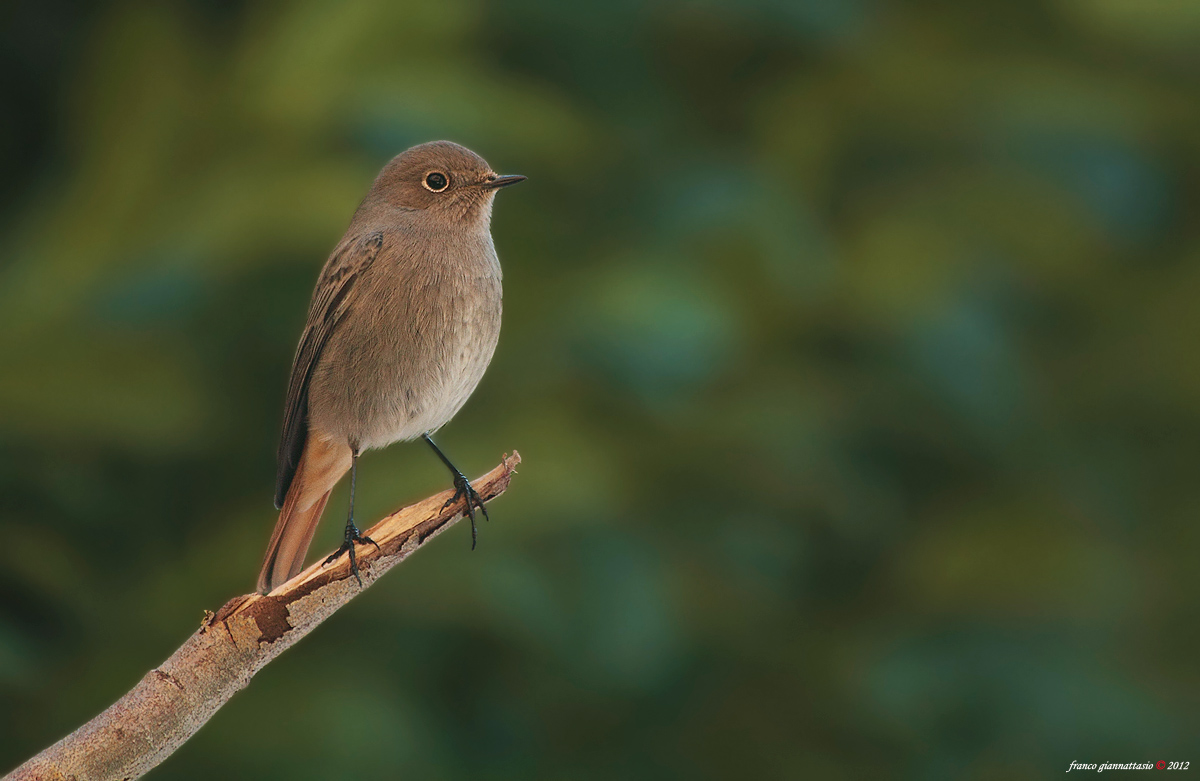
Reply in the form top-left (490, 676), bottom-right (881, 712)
top-left (258, 142), bottom-right (524, 594)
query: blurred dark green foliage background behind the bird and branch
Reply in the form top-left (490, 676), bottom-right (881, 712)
top-left (0, 0), bottom-right (1200, 779)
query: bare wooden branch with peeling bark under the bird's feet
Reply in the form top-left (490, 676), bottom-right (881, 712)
top-left (6, 451), bottom-right (521, 781)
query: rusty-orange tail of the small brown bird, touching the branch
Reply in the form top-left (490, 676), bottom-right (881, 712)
top-left (258, 437), bottom-right (350, 594)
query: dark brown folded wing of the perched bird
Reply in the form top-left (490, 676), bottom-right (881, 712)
top-left (275, 233), bottom-right (383, 509)
